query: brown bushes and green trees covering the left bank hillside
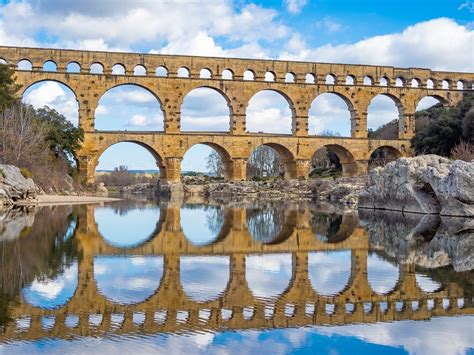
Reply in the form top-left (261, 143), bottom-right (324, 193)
top-left (0, 65), bottom-right (84, 192)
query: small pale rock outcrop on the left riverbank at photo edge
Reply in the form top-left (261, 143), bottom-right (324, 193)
top-left (0, 164), bottom-right (36, 208)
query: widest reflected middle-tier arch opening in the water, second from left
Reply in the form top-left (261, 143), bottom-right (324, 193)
top-left (94, 256), bottom-right (163, 304)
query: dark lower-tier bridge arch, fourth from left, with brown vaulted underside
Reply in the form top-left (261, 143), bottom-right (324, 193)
top-left (311, 144), bottom-right (357, 176)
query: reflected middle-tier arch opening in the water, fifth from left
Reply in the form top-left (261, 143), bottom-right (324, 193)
top-left (308, 250), bottom-right (351, 296)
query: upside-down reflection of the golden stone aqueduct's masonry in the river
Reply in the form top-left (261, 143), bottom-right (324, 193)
top-left (0, 204), bottom-right (474, 343)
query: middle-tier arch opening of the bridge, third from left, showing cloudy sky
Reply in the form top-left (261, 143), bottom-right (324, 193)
top-left (181, 87), bottom-right (232, 132)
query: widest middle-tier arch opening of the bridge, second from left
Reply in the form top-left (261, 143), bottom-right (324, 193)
top-left (94, 84), bottom-right (164, 131)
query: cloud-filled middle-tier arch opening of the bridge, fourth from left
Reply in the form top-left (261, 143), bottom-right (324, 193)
top-left (246, 90), bottom-right (294, 134)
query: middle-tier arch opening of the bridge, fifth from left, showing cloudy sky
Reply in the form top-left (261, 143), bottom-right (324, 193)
top-left (308, 93), bottom-right (353, 137)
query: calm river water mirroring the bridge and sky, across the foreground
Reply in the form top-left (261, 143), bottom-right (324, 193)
top-left (0, 200), bottom-right (474, 354)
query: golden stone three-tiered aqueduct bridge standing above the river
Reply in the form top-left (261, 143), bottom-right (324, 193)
top-left (0, 47), bottom-right (474, 182)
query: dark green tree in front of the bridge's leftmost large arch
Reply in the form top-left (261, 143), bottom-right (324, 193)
top-left (36, 106), bottom-right (84, 161)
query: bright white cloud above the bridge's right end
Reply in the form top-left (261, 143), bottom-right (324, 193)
top-left (280, 18), bottom-right (474, 72)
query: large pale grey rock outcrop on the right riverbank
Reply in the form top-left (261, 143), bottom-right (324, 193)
top-left (359, 155), bottom-right (474, 217)
